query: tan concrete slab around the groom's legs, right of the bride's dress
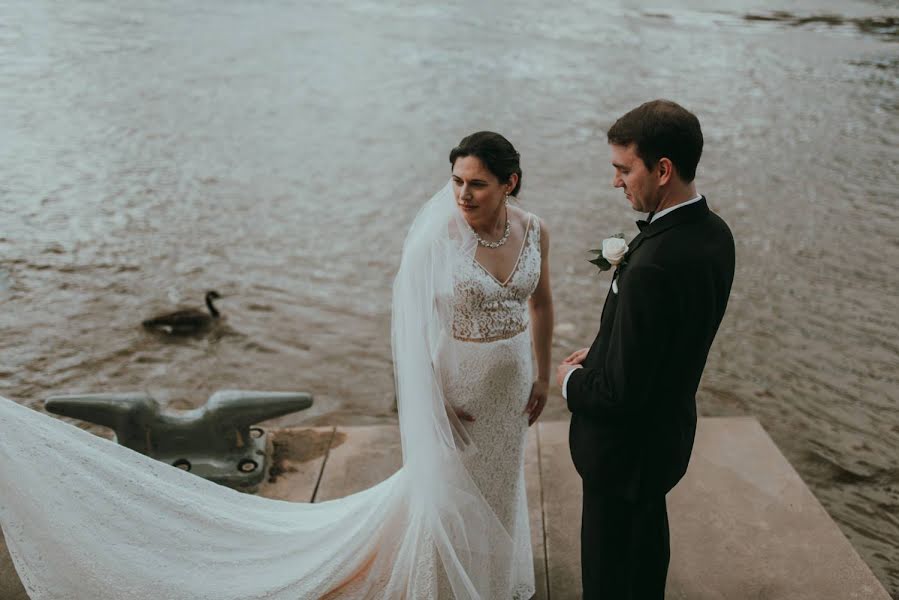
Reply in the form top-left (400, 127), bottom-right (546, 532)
top-left (539, 418), bottom-right (889, 600)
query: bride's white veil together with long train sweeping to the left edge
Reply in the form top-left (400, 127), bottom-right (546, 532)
top-left (0, 184), bottom-right (513, 600)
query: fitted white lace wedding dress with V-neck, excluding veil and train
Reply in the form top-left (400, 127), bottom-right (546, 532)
top-left (441, 215), bottom-right (540, 600)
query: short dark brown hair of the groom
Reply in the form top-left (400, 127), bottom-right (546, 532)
top-left (608, 100), bottom-right (702, 183)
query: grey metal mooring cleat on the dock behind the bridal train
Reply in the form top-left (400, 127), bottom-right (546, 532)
top-left (45, 390), bottom-right (312, 492)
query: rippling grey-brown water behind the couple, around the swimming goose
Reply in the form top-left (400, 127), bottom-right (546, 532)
top-left (0, 0), bottom-right (899, 595)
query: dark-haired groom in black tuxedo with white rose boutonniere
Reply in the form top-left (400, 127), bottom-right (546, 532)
top-left (557, 100), bottom-right (734, 600)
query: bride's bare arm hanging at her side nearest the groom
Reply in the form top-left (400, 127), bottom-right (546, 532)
top-left (527, 221), bottom-right (553, 423)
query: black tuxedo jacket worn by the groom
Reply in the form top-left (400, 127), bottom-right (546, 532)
top-left (567, 197), bottom-right (734, 498)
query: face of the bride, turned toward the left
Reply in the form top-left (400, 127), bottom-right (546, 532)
top-left (453, 156), bottom-right (515, 224)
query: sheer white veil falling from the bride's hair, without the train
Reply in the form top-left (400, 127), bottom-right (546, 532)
top-left (384, 183), bottom-right (513, 598)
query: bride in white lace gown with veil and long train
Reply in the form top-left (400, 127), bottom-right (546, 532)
top-left (0, 132), bottom-right (553, 600)
